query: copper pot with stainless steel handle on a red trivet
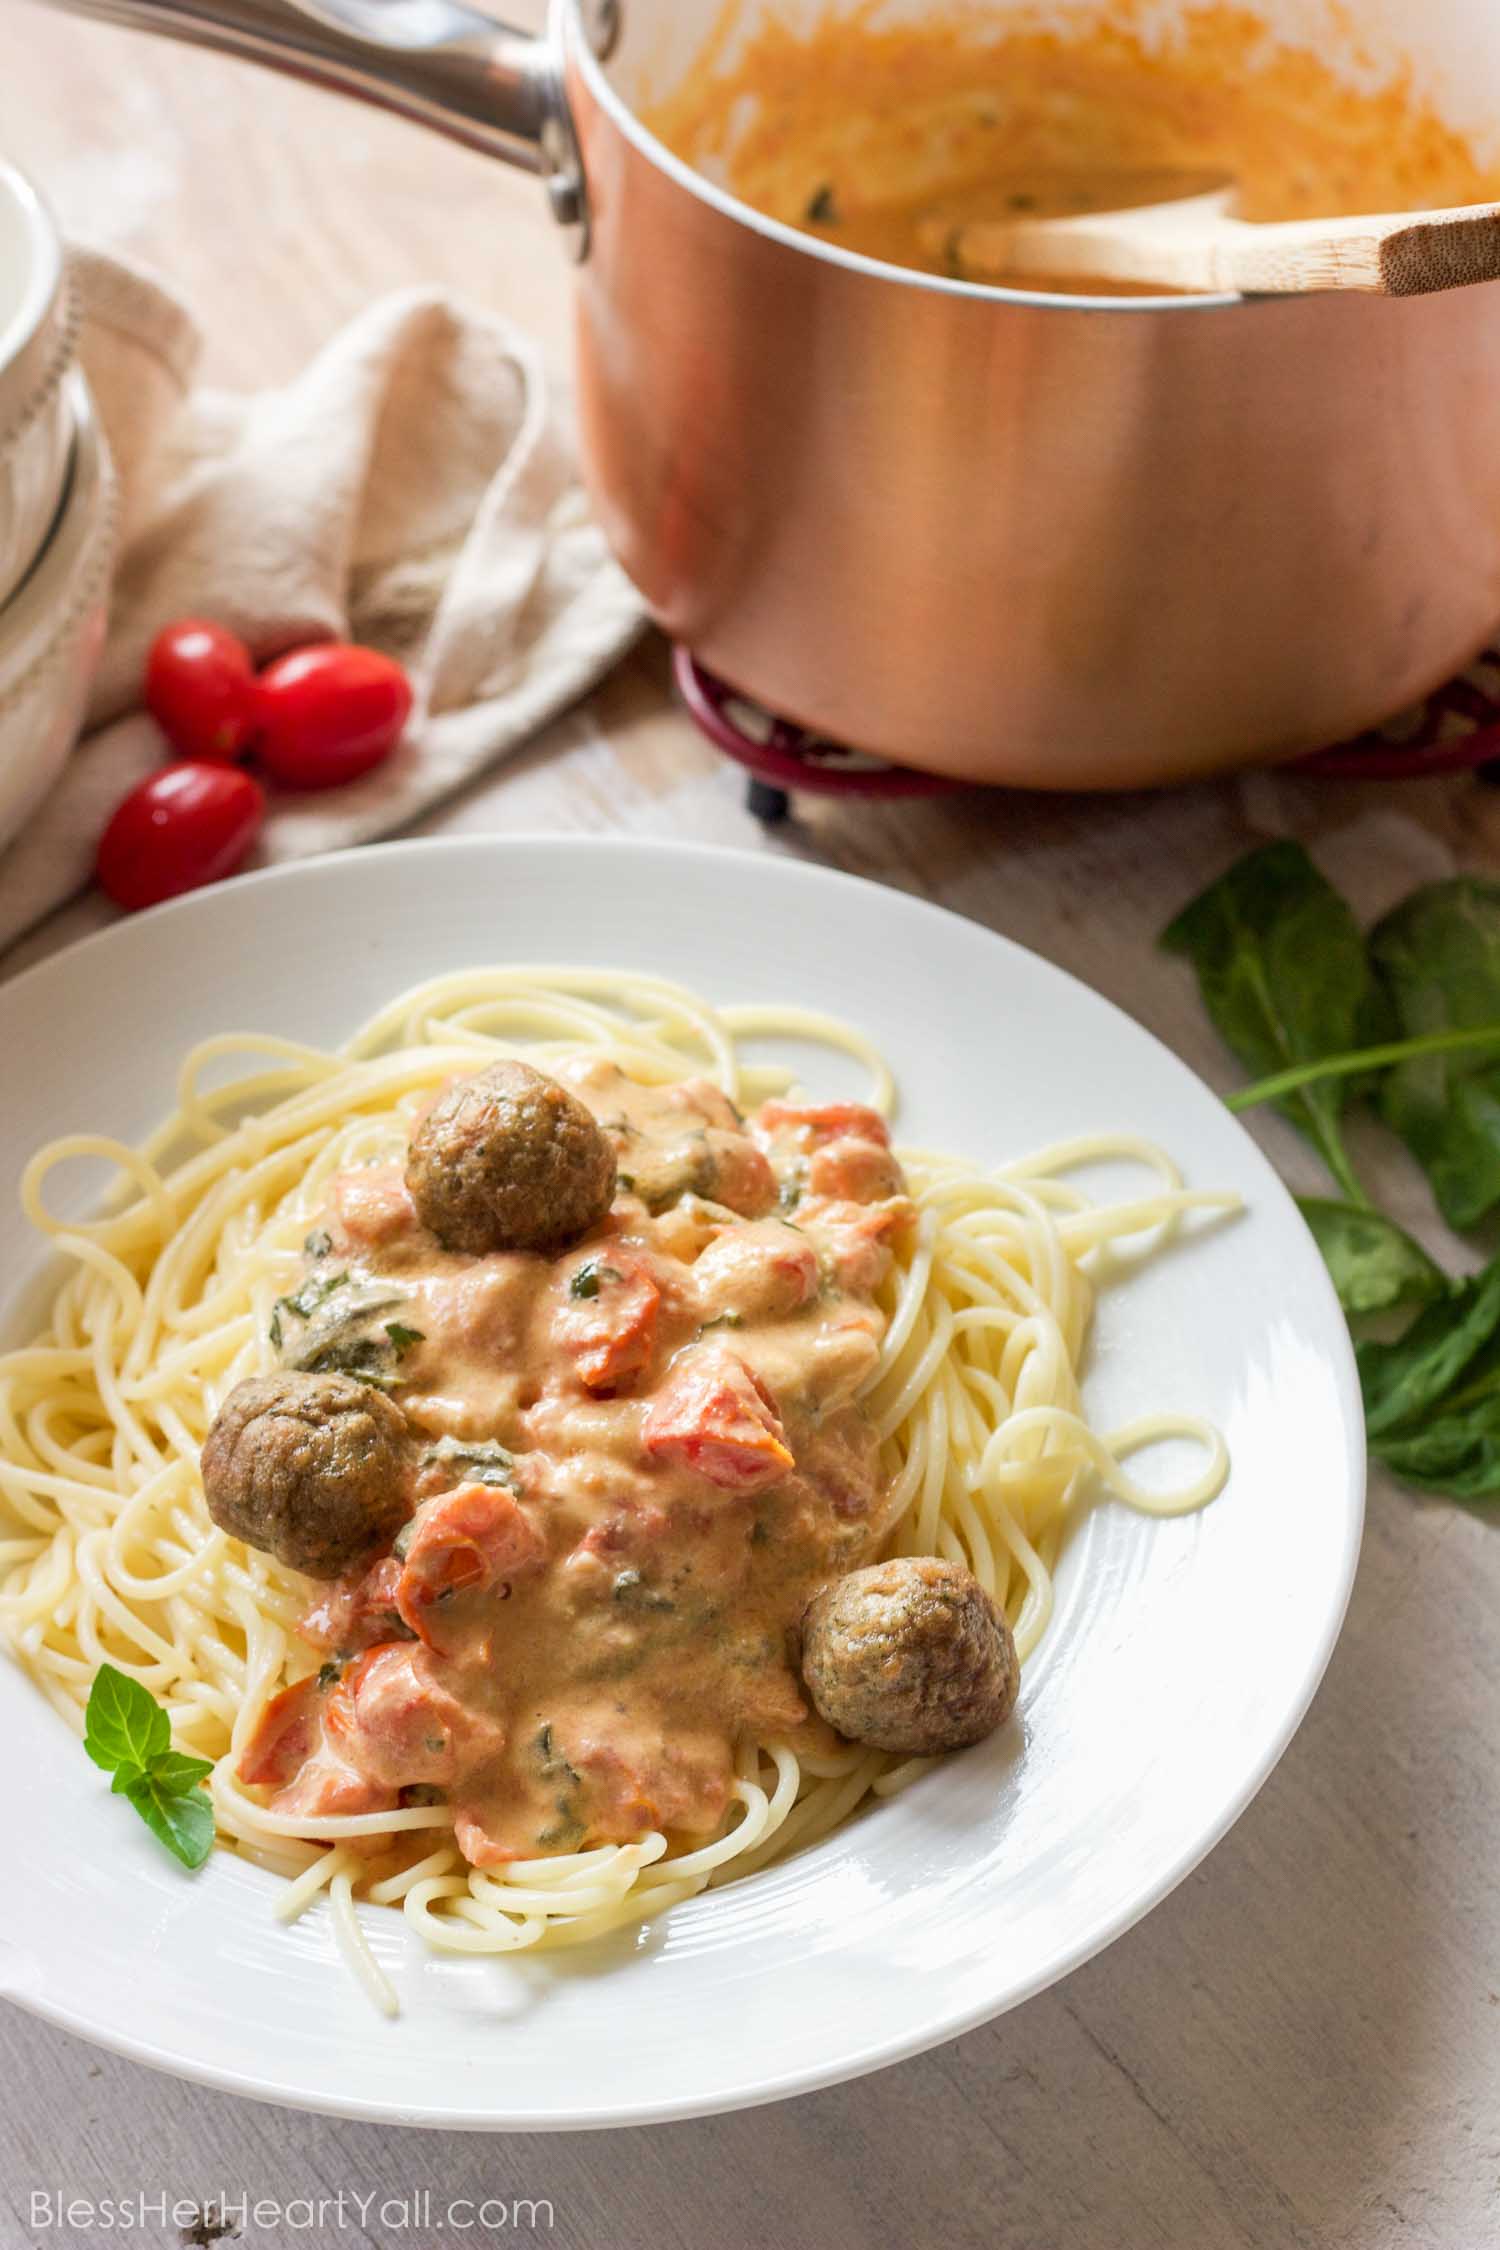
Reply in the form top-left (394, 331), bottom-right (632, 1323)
top-left (32, 0), bottom-right (1500, 788)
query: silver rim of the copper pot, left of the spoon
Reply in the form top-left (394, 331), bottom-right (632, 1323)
top-left (562, 0), bottom-right (1271, 317)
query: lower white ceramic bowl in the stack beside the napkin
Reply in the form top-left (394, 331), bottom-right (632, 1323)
top-left (0, 369), bottom-right (115, 846)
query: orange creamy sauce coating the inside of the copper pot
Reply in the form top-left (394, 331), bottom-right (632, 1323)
top-left (643, 5), bottom-right (1500, 295)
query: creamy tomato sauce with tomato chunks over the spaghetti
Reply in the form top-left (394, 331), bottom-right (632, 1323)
top-left (238, 1060), bottom-right (911, 1865)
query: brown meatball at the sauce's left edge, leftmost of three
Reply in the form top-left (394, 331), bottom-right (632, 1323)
top-left (202, 1370), bottom-right (412, 1577)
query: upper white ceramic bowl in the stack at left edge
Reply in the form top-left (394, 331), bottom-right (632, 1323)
top-left (0, 164), bottom-right (74, 603)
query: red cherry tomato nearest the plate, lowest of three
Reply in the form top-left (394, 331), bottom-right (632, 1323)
top-left (94, 758), bottom-right (265, 909)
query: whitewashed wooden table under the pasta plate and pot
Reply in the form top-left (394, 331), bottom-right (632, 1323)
top-left (0, 0), bottom-right (1500, 2250)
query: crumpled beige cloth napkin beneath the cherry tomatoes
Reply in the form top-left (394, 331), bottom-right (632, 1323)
top-left (0, 252), bottom-right (641, 945)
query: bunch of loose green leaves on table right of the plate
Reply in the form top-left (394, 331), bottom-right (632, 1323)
top-left (1163, 844), bottom-right (1500, 1501)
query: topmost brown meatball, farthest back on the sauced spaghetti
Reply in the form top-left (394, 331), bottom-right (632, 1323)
top-left (407, 1062), bottom-right (614, 1256)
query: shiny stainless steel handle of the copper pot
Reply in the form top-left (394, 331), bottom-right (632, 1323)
top-left (29, 0), bottom-right (587, 257)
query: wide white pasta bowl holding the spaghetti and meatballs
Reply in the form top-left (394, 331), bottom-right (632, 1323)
top-left (0, 837), bottom-right (1363, 2129)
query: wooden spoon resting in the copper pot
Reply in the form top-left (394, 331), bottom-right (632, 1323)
top-left (922, 173), bottom-right (1500, 297)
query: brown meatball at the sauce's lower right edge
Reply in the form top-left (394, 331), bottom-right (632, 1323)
top-left (803, 1555), bottom-right (1021, 1757)
